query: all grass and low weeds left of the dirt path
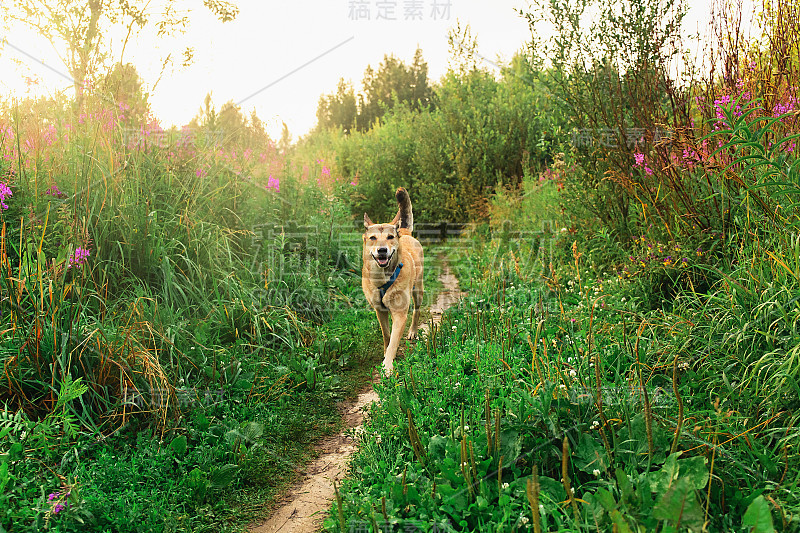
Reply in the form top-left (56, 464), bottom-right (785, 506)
top-left (0, 91), bottom-right (390, 531)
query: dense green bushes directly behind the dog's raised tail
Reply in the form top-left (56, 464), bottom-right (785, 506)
top-left (335, 56), bottom-right (562, 222)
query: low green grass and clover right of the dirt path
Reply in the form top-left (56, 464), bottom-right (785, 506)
top-left (326, 232), bottom-right (800, 531)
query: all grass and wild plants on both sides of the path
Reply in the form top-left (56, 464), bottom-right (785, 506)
top-left (0, 4), bottom-right (800, 532)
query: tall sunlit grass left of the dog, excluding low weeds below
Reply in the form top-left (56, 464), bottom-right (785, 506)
top-left (0, 92), bottom-right (360, 431)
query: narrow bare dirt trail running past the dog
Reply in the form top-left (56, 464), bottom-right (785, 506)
top-left (250, 257), bottom-right (464, 533)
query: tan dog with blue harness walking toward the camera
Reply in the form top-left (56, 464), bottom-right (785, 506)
top-left (361, 187), bottom-right (424, 376)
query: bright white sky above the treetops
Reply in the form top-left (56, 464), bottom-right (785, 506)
top-left (0, 0), bottom-right (710, 139)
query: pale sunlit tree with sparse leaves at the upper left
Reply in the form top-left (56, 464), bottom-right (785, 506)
top-left (0, 0), bottom-right (239, 109)
